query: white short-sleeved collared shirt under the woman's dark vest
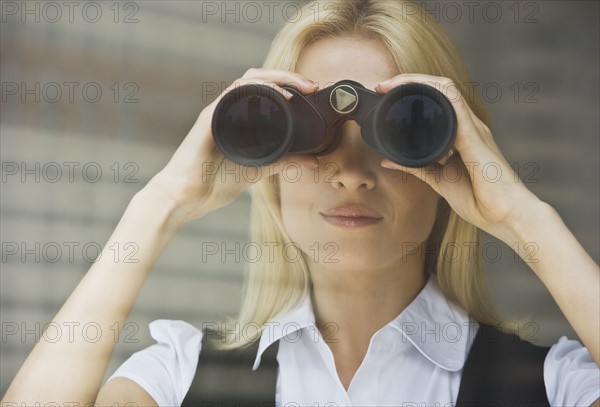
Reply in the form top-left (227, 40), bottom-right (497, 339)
top-left (109, 278), bottom-right (600, 407)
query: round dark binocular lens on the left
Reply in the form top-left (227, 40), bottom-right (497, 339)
top-left (213, 87), bottom-right (291, 164)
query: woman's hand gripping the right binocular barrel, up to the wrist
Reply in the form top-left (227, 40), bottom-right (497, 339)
top-left (376, 74), bottom-right (540, 242)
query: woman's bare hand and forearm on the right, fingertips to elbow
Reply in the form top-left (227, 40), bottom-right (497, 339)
top-left (377, 74), bottom-right (600, 370)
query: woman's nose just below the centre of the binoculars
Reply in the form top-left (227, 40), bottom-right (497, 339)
top-left (320, 120), bottom-right (379, 191)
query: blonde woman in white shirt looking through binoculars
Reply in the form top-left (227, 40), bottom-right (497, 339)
top-left (5, 0), bottom-right (600, 406)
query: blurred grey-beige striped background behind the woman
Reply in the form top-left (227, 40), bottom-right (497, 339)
top-left (0, 1), bottom-right (600, 394)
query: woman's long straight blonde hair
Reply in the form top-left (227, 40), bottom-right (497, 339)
top-left (222, 0), bottom-right (503, 348)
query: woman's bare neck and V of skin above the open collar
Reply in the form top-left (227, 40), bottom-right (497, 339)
top-left (309, 247), bottom-right (426, 389)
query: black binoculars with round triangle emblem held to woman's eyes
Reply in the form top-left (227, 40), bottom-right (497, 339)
top-left (212, 80), bottom-right (457, 167)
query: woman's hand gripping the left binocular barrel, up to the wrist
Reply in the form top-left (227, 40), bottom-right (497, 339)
top-left (144, 68), bottom-right (318, 230)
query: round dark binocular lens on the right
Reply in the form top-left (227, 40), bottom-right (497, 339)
top-left (377, 89), bottom-right (454, 166)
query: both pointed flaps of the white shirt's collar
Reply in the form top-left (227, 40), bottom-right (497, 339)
top-left (252, 277), bottom-right (477, 371)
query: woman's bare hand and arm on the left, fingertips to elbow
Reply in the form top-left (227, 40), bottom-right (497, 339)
top-left (2, 69), bottom-right (316, 405)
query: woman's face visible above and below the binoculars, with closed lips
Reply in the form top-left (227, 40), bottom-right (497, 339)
top-left (279, 37), bottom-right (438, 271)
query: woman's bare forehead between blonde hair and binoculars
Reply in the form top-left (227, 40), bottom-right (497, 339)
top-left (296, 36), bottom-right (400, 89)
